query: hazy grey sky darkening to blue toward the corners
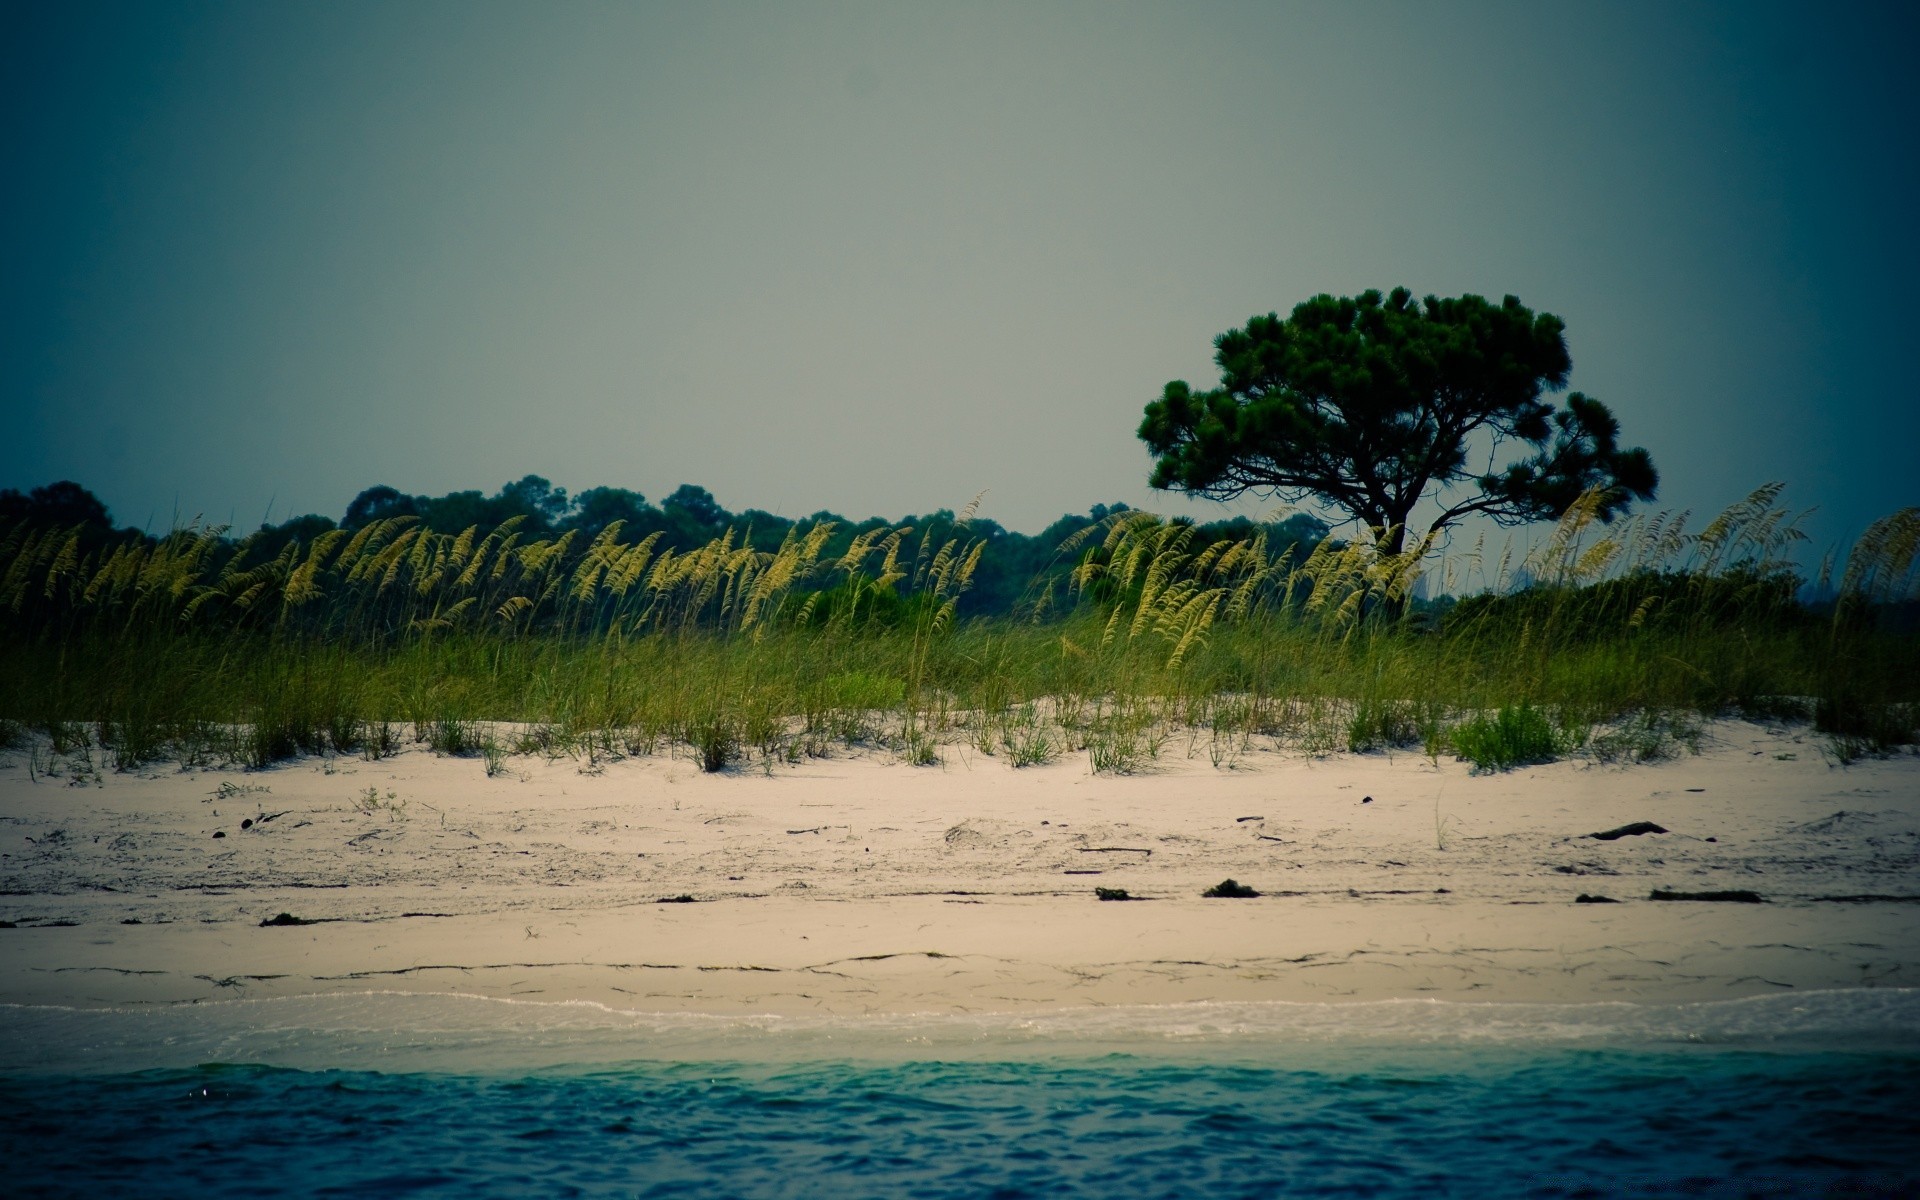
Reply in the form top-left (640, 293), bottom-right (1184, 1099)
top-left (0, 0), bottom-right (1920, 543)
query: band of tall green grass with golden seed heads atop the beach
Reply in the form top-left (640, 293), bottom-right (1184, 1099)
top-left (0, 486), bottom-right (1920, 772)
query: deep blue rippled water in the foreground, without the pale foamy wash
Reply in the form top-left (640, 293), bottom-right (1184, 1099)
top-left (0, 1046), bottom-right (1920, 1196)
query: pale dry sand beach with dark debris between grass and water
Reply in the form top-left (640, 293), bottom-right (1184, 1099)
top-left (0, 722), bottom-right (1920, 1014)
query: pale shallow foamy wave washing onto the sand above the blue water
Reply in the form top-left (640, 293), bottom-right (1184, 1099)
top-left (0, 989), bottom-right (1920, 1073)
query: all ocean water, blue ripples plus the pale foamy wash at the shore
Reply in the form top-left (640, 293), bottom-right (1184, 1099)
top-left (0, 991), bottom-right (1920, 1198)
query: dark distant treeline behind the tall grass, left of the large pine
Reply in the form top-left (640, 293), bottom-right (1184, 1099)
top-left (0, 474), bottom-right (1329, 616)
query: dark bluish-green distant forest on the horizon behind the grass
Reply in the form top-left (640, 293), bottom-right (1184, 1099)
top-left (0, 474), bottom-right (1329, 616)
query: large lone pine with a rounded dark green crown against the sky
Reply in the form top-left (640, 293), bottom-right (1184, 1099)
top-left (1139, 288), bottom-right (1659, 553)
